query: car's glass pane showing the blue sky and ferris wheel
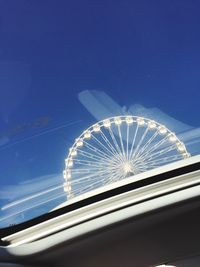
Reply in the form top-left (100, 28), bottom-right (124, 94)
top-left (0, 0), bottom-right (200, 227)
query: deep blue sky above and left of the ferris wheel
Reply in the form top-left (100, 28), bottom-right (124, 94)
top-left (0, 0), bottom-right (200, 226)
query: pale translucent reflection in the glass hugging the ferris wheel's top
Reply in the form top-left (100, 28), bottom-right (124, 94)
top-left (78, 90), bottom-right (200, 157)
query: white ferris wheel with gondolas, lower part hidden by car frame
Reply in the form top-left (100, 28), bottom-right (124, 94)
top-left (63, 116), bottom-right (190, 199)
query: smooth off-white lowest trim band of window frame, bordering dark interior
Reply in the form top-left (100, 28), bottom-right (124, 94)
top-left (6, 185), bottom-right (200, 256)
